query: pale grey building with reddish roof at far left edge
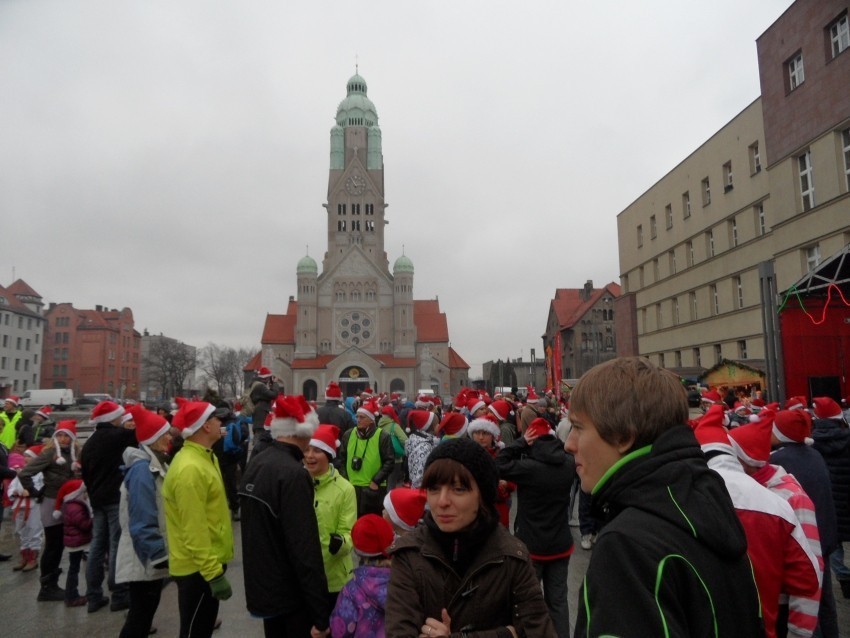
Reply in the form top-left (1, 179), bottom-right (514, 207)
top-left (0, 279), bottom-right (49, 398)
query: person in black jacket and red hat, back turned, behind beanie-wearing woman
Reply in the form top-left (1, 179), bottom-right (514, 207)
top-left (496, 418), bottom-right (576, 638)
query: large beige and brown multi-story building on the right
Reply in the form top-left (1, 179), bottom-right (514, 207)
top-left (617, 0), bottom-right (850, 394)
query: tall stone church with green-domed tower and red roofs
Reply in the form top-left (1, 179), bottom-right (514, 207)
top-left (254, 74), bottom-right (469, 399)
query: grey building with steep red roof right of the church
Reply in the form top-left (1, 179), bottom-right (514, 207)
top-left (543, 280), bottom-right (620, 379)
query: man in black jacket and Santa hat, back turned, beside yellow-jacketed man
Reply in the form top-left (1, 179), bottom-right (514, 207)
top-left (239, 397), bottom-right (331, 636)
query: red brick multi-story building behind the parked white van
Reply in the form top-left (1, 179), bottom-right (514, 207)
top-left (41, 303), bottom-right (140, 399)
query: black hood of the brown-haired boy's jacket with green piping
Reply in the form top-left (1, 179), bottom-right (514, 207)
top-left (592, 425), bottom-right (747, 558)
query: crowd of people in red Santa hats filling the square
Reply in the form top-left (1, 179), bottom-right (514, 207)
top-left (0, 357), bottom-right (850, 638)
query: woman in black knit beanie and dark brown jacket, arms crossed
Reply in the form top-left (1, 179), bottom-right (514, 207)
top-left (386, 437), bottom-right (556, 638)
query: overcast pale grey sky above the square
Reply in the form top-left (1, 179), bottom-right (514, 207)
top-left (0, 0), bottom-right (791, 376)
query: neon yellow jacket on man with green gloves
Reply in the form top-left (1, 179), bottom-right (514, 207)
top-left (162, 441), bottom-right (233, 581)
